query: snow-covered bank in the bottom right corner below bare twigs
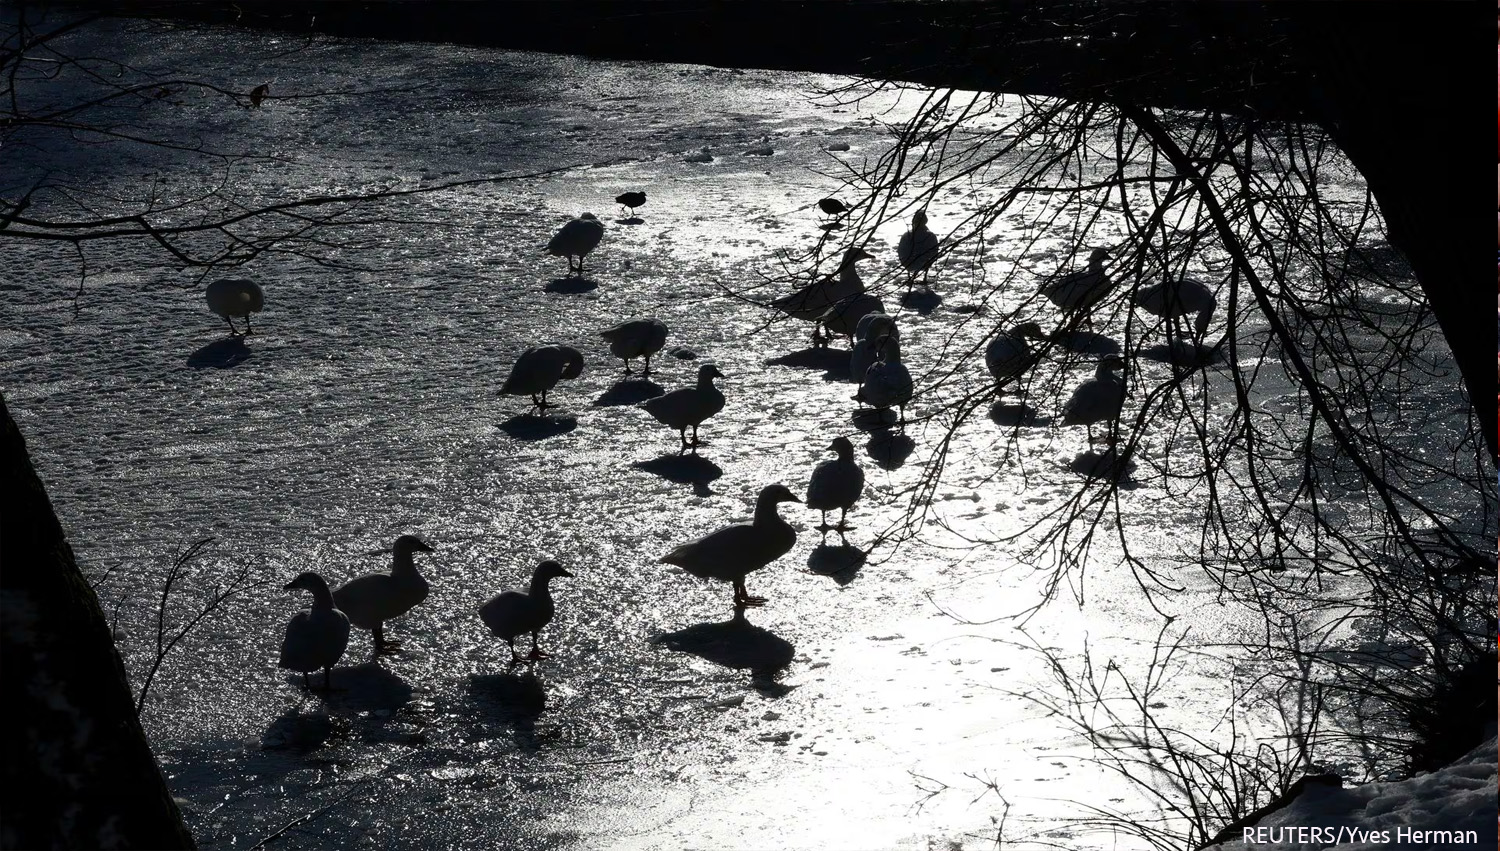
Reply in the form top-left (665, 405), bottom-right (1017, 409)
top-left (1205, 738), bottom-right (1497, 851)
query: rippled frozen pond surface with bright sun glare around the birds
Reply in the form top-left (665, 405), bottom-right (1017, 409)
top-left (0, 15), bottom-right (1476, 849)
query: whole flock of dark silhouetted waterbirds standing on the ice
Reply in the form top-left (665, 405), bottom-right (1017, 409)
top-left (217, 192), bottom-right (1217, 687)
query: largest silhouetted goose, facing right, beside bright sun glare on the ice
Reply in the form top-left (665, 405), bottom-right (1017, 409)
top-left (660, 485), bottom-right (801, 606)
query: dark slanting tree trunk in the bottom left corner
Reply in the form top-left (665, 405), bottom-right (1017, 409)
top-left (0, 396), bottom-right (194, 848)
